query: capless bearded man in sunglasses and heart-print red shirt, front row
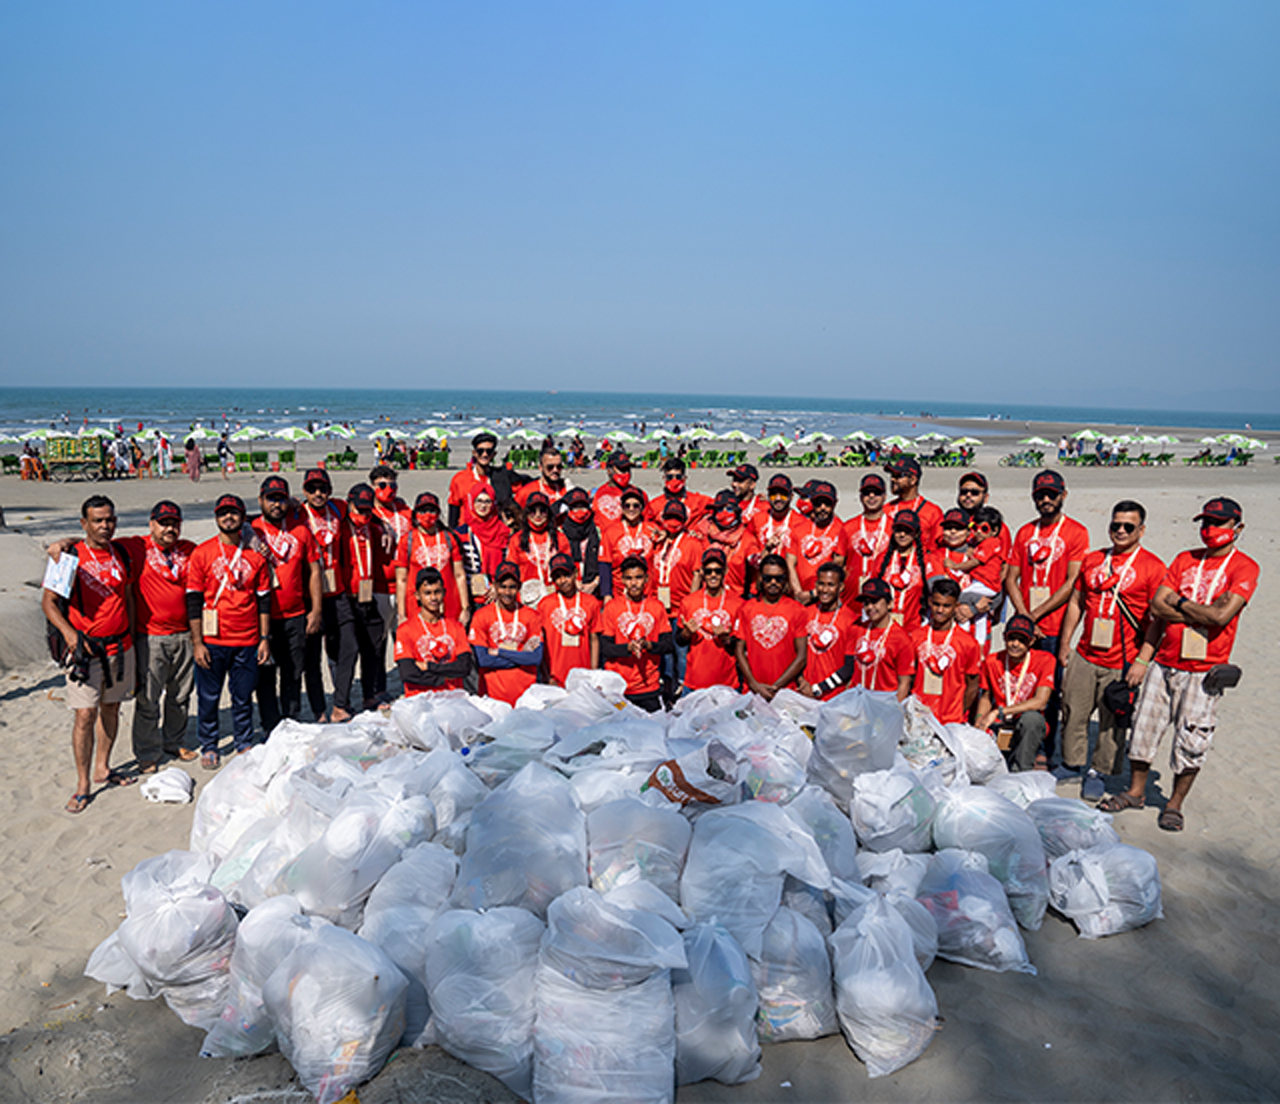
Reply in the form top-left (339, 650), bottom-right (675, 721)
top-left (733, 552), bottom-right (809, 702)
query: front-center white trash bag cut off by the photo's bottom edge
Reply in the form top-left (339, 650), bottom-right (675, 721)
top-left (534, 964), bottom-right (676, 1104)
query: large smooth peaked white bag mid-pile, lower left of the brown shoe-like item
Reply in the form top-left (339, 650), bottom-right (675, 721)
top-left (453, 763), bottom-right (588, 918)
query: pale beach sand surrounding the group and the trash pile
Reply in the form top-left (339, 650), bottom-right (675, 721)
top-left (0, 435), bottom-right (1280, 1104)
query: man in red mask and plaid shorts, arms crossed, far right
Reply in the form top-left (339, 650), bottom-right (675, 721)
top-left (1098, 498), bottom-right (1258, 831)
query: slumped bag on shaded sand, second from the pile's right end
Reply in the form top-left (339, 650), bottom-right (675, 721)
top-left (916, 848), bottom-right (1036, 973)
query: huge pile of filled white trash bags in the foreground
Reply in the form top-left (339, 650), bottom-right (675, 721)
top-left (86, 671), bottom-right (1161, 1104)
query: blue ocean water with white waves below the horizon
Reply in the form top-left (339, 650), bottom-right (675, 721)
top-left (0, 387), bottom-right (1280, 439)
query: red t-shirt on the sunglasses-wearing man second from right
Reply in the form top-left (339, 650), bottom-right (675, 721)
top-left (1075, 546), bottom-right (1165, 671)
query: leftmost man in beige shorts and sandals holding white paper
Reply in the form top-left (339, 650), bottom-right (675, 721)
top-left (41, 494), bottom-right (137, 813)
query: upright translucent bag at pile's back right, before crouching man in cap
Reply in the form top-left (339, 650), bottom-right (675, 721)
top-left (809, 686), bottom-right (902, 811)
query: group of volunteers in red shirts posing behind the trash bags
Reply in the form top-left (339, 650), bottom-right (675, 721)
top-left (44, 433), bottom-right (1258, 831)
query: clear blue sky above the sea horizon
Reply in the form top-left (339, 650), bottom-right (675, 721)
top-left (0, 0), bottom-right (1280, 410)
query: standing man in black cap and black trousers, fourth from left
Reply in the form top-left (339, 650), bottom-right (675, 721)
top-left (247, 475), bottom-right (323, 735)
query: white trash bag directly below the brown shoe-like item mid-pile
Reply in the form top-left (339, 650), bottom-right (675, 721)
top-left (586, 798), bottom-right (692, 900)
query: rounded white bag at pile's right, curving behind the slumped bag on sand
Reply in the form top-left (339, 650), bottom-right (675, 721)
top-left (933, 786), bottom-right (1048, 931)
